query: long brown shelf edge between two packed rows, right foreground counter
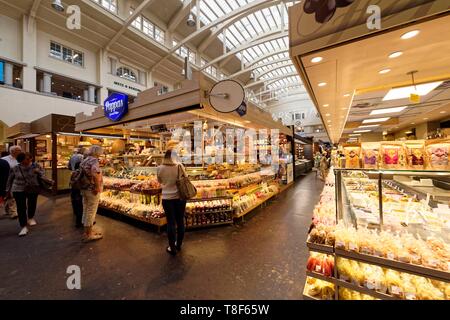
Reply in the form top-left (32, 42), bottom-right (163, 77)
top-left (335, 249), bottom-right (450, 282)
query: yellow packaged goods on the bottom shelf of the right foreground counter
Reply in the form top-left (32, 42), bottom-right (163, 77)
top-left (336, 258), bottom-right (450, 300)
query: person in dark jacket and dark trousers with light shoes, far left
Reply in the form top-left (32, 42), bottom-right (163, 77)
top-left (6, 153), bottom-right (44, 236)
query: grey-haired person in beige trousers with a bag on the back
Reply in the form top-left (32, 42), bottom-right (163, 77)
top-left (80, 146), bottom-right (103, 241)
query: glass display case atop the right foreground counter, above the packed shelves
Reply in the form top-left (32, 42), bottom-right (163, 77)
top-left (335, 169), bottom-right (450, 240)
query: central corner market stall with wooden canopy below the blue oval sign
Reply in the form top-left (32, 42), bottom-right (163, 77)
top-left (76, 74), bottom-right (293, 229)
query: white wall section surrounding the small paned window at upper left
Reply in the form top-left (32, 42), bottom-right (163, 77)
top-left (37, 30), bottom-right (97, 83)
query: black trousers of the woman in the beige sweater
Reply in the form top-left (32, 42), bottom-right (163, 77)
top-left (162, 199), bottom-right (186, 250)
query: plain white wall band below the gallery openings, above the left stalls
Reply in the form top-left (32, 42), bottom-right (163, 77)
top-left (0, 86), bottom-right (95, 126)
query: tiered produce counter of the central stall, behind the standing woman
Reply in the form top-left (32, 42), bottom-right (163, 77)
top-left (100, 165), bottom-right (280, 229)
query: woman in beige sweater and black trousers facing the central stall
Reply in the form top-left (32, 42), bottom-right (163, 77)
top-left (157, 148), bottom-right (186, 255)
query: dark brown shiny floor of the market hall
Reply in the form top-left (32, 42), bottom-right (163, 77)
top-left (0, 174), bottom-right (323, 299)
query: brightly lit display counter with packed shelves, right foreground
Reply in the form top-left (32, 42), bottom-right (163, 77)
top-left (304, 169), bottom-right (450, 300)
